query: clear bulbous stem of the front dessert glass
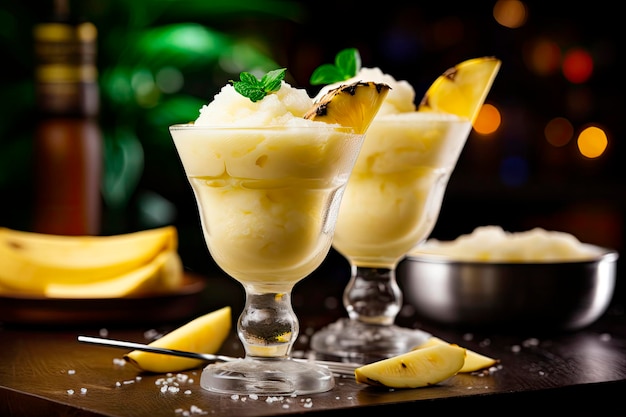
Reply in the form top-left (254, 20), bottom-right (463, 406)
top-left (237, 287), bottom-right (299, 358)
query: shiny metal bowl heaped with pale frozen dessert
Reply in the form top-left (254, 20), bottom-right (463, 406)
top-left (398, 226), bottom-right (618, 334)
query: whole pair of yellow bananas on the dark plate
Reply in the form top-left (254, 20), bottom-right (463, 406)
top-left (0, 226), bottom-right (183, 298)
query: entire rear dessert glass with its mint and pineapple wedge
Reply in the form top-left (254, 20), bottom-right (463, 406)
top-left (311, 49), bottom-right (500, 362)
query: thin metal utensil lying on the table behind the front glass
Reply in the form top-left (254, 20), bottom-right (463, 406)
top-left (78, 336), bottom-right (362, 376)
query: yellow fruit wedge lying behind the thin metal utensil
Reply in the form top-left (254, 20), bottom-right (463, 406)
top-left (124, 307), bottom-right (231, 373)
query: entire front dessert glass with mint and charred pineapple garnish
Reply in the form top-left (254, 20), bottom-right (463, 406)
top-left (170, 70), bottom-right (389, 395)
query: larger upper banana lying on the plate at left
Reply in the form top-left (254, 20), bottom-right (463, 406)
top-left (0, 226), bottom-right (178, 294)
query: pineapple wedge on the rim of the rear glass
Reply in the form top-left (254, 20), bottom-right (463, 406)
top-left (418, 57), bottom-right (501, 123)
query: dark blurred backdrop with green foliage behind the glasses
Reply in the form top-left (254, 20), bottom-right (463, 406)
top-left (0, 0), bottom-right (626, 306)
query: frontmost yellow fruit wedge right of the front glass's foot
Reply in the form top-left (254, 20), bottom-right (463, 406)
top-left (354, 343), bottom-right (465, 388)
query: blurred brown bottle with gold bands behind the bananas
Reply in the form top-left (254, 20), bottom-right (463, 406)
top-left (33, 0), bottom-right (103, 235)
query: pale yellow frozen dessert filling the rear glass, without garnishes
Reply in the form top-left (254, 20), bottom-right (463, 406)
top-left (322, 68), bottom-right (471, 267)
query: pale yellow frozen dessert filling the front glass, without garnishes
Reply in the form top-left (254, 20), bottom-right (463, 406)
top-left (171, 70), bottom-right (382, 290)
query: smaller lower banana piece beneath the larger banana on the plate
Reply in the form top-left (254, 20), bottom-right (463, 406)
top-left (44, 250), bottom-right (183, 298)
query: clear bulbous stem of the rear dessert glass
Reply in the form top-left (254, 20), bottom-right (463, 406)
top-left (343, 265), bottom-right (402, 325)
